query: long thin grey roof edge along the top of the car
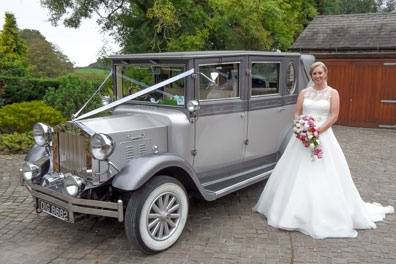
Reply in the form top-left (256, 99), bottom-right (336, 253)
top-left (109, 50), bottom-right (300, 60)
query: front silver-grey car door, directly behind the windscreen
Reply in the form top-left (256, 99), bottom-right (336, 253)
top-left (193, 57), bottom-right (247, 174)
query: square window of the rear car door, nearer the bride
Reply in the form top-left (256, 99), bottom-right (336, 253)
top-left (251, 62), bottom-right (280, 96)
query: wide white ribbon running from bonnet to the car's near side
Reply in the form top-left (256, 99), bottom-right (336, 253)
top-left (73, 69), bottom-right (194, 121)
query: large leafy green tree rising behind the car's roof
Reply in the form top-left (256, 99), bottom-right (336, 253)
top-left (41, 0), bottom-right (316, 52)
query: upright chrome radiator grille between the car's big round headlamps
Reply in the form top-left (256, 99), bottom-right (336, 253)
top-left (53, 127), bottom-right (92, 175)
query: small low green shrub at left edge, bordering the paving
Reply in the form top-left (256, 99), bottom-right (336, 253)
top-left (0, 132), bottom-right (34, 154)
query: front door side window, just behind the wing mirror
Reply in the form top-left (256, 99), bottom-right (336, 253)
top-left (199, 63), bottom-right (239, 100)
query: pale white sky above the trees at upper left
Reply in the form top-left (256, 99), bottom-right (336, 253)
top-left (0, 0), bottom-right (119, 67)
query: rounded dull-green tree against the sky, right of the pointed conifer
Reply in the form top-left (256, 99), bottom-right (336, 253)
top-left (21, 29), bottom-right (73, 77)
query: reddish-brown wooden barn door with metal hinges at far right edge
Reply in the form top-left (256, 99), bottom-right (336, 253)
top-left (376, 62), bottom-right (396, 128)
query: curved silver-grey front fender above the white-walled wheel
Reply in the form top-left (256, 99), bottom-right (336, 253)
top-left (112, 153), bottom-right (203, 193)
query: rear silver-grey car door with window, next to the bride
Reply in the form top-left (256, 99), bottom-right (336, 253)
top-left (245, 56), bottom-right (298, 165)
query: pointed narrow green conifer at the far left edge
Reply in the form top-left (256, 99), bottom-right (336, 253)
top-left (0, 13), bottom-right (27, 76)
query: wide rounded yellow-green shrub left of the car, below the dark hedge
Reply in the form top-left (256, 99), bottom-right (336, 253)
top-left (0, 101), bottom-right (65, 134)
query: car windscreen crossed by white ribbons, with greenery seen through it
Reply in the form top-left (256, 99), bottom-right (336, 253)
top-left (115, 63), bottom-right (186, 106)
